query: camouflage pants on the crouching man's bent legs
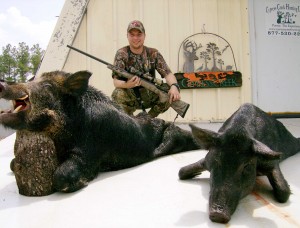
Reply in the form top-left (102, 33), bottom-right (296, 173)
top-left (112, 88), bottom-right (170, 117)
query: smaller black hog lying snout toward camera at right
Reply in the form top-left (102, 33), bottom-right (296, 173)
top-left (179, 104), bottom-right (300, 223)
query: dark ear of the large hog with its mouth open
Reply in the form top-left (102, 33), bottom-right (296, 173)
top-left (64, 71), bottom-right (92, 95)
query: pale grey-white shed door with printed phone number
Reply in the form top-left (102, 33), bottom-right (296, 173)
top-left (249, 0), bottom-right (300, 112)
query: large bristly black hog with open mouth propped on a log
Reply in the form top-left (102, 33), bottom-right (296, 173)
top-left (0, 71), bottom-right (199, 192)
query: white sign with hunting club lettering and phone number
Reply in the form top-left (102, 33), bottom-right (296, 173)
top-left (265, 0), bottom-right (300, 37)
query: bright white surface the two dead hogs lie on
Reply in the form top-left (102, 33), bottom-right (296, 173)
top-left (0, 119), bottom-right (300, 228)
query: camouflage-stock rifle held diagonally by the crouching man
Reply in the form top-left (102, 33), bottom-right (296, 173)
top-left (67, 45), bottom-right (190, 118)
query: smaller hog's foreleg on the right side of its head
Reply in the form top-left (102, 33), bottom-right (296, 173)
top-left (267, 164), bottom-right (291, 203)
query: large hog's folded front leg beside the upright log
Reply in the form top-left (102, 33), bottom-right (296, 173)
top-left (53, 157), bottom-right (89, 192)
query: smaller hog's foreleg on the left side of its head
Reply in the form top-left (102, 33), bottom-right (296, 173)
top-left (178, 158), bottom-right (207, 180)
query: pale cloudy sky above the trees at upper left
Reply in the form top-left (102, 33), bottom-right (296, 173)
top-left (0, 0), bottom-right (65, 50)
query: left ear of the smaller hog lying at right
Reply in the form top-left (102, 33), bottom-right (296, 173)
top-left (190, 124), bottom-right (219, 149)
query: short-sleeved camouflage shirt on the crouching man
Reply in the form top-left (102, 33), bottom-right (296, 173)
top-left (112, 46), bottom-right (171, 81)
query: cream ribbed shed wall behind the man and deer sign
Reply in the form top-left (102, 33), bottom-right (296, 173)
top-left (49, 0), bottom-right (251, 122)
